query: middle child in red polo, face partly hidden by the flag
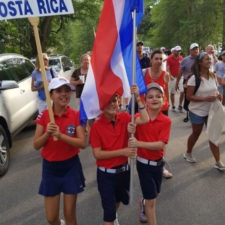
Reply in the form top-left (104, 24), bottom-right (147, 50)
top-left (90, 85), bottom-right (148, 225)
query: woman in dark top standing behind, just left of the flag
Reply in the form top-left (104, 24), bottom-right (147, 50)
top-left (70, 53), bottom-right (91, 109)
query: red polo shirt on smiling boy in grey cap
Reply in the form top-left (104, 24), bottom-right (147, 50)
top-left (136, 113), bottom-right (171, 160)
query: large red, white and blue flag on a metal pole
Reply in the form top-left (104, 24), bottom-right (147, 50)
top-left (80, 0), bottom-right (146, 124)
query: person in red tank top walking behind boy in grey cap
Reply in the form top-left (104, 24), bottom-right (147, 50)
top-left (143, 50), bottom-right (173, 178)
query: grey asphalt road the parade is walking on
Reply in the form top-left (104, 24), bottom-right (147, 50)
top-left (0, 94), bottom-right (225, 225)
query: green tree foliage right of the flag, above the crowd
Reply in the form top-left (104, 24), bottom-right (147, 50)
top-left (142, 0), bottom-right (222, 54)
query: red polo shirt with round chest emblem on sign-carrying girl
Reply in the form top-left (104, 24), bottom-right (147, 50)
top-left (36, 106), bottom-right (80, 161)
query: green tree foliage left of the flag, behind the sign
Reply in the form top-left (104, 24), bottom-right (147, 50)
top-left (0, 0), bottom-right (102, 63)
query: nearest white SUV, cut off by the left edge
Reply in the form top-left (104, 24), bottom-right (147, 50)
top-left (0, 54), bottom-right (37, 176)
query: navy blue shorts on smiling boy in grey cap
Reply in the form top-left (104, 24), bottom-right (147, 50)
top-left (137, 161), bottom-right (164, 200)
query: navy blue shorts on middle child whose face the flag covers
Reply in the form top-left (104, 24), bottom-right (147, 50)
top-left (97, 166), bottom-right (130, 222)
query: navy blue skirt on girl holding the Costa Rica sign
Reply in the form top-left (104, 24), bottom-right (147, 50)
top-left (39, 155), bottom-right (85, 197)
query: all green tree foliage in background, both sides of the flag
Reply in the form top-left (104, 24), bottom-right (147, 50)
top-left (0, 0), bottom-right (225, 60)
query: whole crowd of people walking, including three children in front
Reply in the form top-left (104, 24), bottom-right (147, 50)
top-left (31, 41), bottom-right (225, 225)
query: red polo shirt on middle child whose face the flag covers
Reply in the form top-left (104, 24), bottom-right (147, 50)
top-left (90, 113), bottom-right (131, 168)
